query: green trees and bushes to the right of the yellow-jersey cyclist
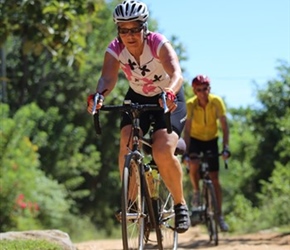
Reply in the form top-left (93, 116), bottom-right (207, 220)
top-left (221, 62), bottom-right (290, 231)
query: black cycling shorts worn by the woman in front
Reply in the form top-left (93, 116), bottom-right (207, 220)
top-left (120, 88), bottom-right (186, 137)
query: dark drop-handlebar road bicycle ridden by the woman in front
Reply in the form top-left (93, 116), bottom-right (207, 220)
top-left (94, 94), bottom-right (177, 250)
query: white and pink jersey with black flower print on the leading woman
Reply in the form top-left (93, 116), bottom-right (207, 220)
top-left (107, 32), bottom-right (170, 96)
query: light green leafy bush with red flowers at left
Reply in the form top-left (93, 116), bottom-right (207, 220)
top-left (0, 104), bottom-right (71, 231)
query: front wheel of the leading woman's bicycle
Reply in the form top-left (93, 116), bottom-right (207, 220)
top-left (121, 154), bottom-right (145, 250)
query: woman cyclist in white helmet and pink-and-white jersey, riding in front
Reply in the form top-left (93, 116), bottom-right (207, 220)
top-left (88, 0), bottom-right (190, 233)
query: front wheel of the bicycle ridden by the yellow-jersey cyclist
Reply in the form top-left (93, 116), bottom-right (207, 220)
top-left (204, 181), bottom-right (218, 246)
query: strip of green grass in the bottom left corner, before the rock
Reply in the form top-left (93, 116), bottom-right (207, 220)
top-left (0, 239), bottom-right (62, 250)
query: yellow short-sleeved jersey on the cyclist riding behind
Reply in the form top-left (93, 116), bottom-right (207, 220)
top-left (186, 94), bottom-right (226, 141)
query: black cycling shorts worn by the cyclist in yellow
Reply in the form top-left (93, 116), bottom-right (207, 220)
top-left (188, 137), bottom-right (219, 172)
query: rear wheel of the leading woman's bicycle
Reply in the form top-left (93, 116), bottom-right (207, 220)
top-left (153, 177), bottom-right (178, 250)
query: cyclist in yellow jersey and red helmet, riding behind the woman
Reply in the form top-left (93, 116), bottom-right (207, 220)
top-left (184, 75), bottom-right (230, 231)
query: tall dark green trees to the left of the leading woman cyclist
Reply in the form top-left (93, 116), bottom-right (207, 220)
top-left (0, 0), bottom-right (199, 236)
